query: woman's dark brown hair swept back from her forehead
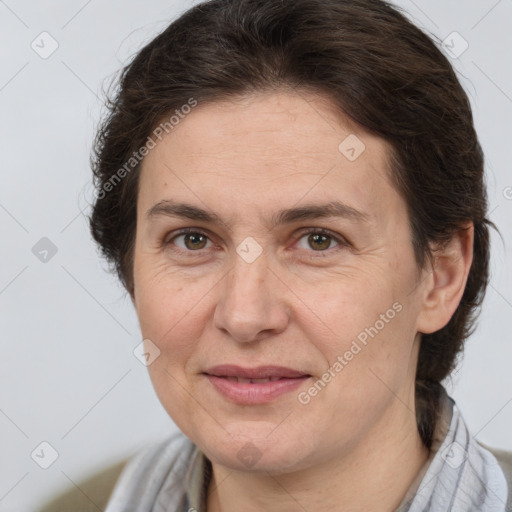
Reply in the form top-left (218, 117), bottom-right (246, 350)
top-left (90, 0), bottom-right (491, 448)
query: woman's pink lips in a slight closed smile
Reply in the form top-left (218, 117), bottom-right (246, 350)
top-left (204, 365), bottom-right (311, 405)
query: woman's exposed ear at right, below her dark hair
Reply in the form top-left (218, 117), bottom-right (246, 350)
top-left (417, 222), bottom-right (474, 334)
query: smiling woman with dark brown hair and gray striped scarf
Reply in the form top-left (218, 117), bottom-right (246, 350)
top-left (91, 0), bottom-right (510, 512)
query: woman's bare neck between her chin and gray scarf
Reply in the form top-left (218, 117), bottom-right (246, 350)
top-left (207, 400), bottom-right (429, 512)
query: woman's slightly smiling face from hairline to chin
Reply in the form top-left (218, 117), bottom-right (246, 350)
top-left (133, 91), bottom-right (428, 471)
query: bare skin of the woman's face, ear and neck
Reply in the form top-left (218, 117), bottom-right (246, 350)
top-left (132, 90), bottom-right (473, 512)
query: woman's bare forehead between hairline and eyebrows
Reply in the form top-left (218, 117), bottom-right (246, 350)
top-left (139, 92), bottom-right (396, 224)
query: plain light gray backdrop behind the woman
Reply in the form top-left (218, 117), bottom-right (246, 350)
top-left (0, 0), bottom-right (512, 512)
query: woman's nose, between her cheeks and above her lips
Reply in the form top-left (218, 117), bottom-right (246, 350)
top-left (214, 249), bottom-right (289, 343)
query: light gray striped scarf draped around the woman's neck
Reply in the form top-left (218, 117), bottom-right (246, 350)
top-left (105, 394), bottom-right (509, 512)
